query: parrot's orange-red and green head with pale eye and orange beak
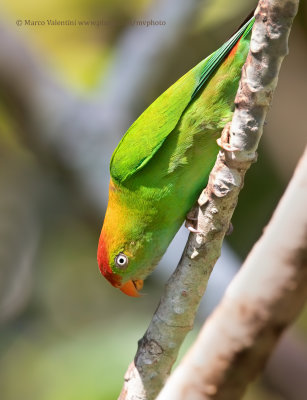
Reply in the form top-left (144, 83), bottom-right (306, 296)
top-left (97, 181), bottom-right (156, 297)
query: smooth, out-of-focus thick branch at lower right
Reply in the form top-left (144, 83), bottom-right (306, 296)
top-left (158, 148), bottom-right (307, 400)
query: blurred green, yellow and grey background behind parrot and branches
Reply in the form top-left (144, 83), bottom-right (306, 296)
top-left (0, 0), bottom-right (307, 400)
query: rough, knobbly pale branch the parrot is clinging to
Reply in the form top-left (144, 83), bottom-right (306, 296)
top-left (119, 0), bottom-right (298, 400)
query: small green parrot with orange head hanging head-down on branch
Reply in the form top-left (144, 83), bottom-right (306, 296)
top-left (97, 17), bottom-right (254, 297)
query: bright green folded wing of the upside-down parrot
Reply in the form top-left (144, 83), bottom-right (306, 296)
top-left (110, 18), bottom-right (254, 183)
